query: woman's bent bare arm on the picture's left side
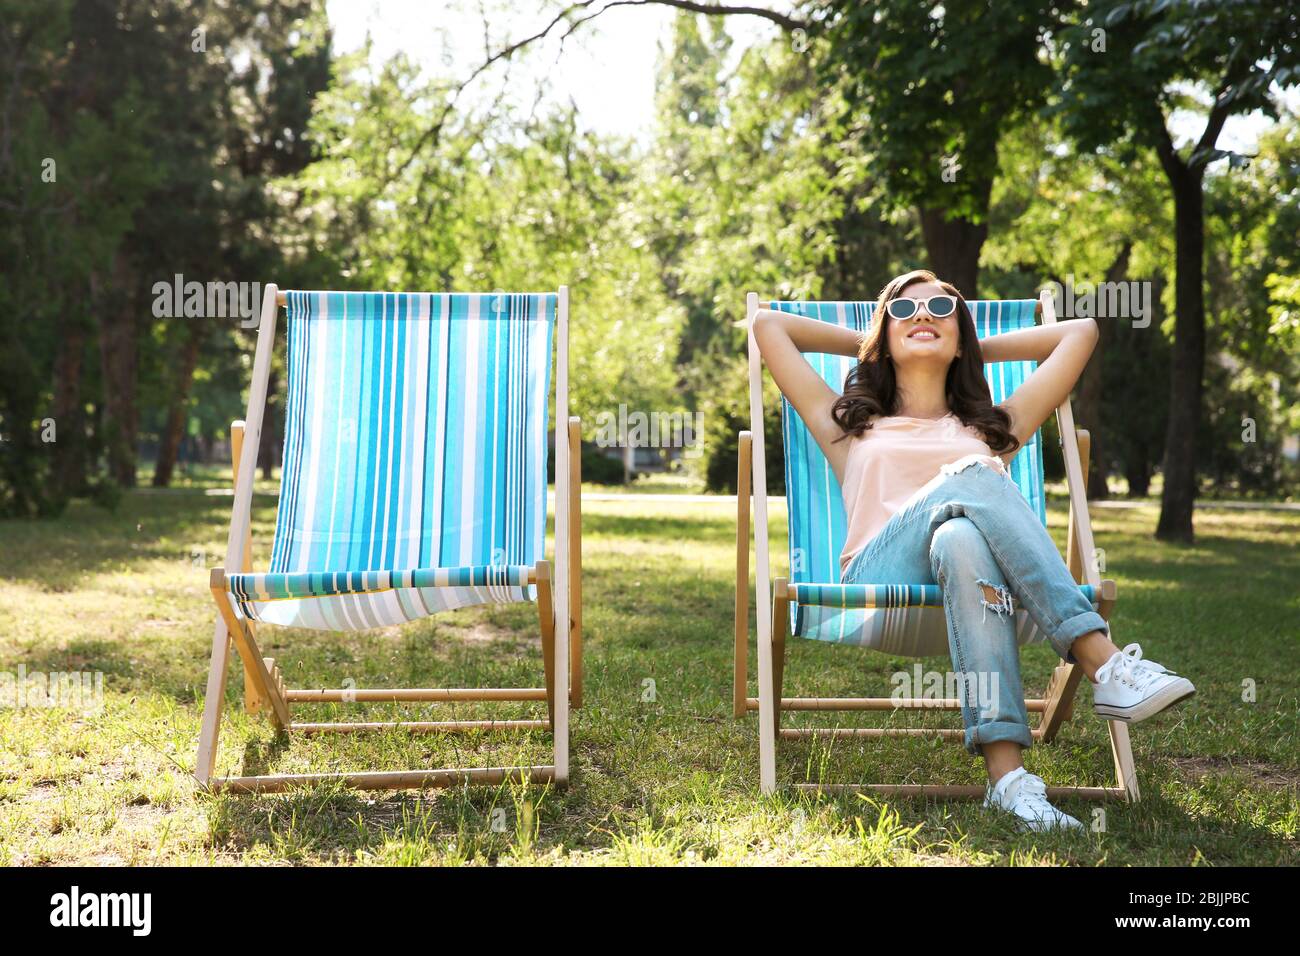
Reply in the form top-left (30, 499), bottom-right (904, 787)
top-left (754, 308), bottom-right (862, 481)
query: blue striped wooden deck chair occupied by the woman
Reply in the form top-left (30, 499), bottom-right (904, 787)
top-left (733, 293), bottom-right (1139, 801)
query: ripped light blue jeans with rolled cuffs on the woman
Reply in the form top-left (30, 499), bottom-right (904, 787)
top-left (841, 459), bottom-right (1110, 754)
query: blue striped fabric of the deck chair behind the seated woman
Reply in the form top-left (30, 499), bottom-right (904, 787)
top-left (771, 299), bottom-right (1096, 657)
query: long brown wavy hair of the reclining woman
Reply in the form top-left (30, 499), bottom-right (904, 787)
top-left (831, 269), bottom-right (1021, 454)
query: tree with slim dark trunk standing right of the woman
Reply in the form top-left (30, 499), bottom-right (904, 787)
top-left (1061, 0), bottom-right (1300, 541)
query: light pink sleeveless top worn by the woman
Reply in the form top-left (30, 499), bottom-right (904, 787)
top-left (840, 412), bottom-right (1010, 576)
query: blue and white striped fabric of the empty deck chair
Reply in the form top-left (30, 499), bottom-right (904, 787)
top-left (228, 293), bottom-right (556, 631)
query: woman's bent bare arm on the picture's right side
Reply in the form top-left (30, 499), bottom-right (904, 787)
top-left (980, 319), bottom-right (1097, 442)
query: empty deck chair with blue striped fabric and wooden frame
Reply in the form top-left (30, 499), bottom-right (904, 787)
top-left (195, 285), bottom-right (581, 792)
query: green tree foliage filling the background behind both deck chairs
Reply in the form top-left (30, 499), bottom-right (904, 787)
top-left (0, 0), bottom-right (1300, 515)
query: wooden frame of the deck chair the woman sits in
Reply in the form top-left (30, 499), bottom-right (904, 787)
top-left (732, 291), bottom-right (1140, 803)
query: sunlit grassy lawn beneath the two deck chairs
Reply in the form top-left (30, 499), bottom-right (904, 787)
top-left (0, 476), bottom-right (1300, 865)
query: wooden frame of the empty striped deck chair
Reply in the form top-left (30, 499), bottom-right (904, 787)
top-left (195, 284), bottom-right (582, 793)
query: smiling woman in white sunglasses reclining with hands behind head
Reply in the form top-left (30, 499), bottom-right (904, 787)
top-left (754, 271), bottom-right (1195, 830)
